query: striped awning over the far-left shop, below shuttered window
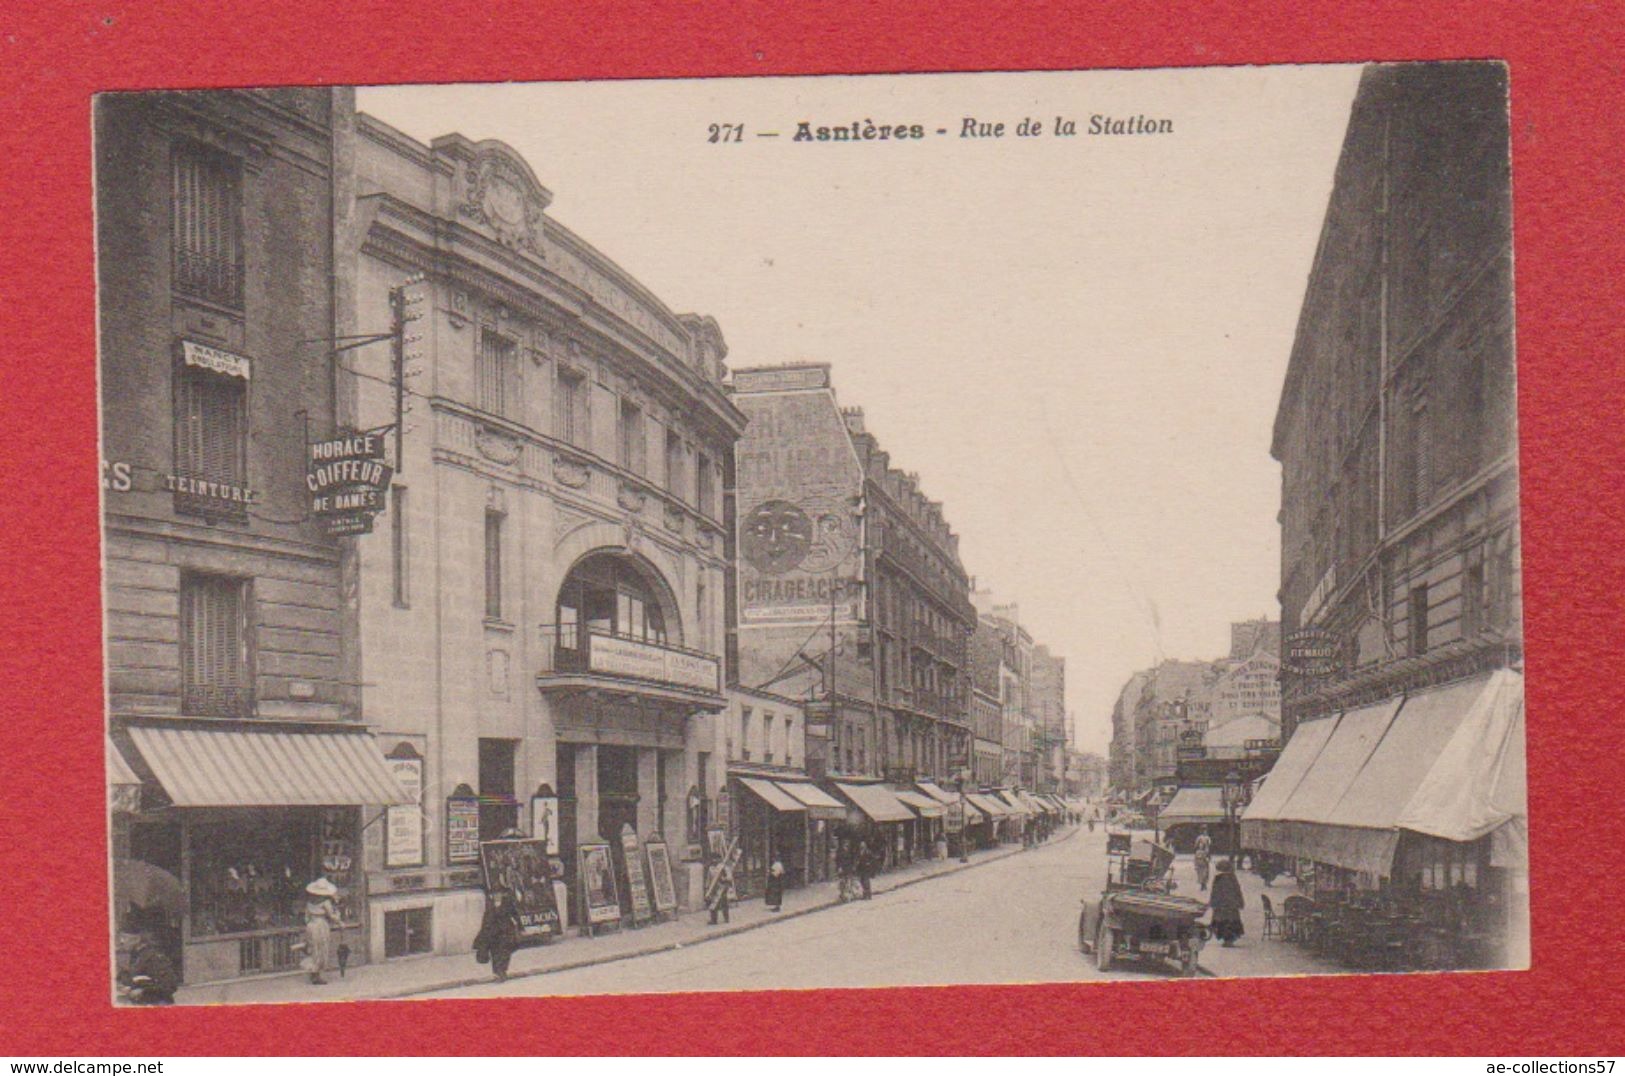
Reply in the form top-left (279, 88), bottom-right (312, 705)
top-left (130, 725), bottom-right (413, 806)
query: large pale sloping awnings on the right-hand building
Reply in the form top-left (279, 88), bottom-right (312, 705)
top-left (1241, 670), bottom-right (1526, 874)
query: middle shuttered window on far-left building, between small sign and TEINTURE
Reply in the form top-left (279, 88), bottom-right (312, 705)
top-left (176, 366), bottom-right (249, 518)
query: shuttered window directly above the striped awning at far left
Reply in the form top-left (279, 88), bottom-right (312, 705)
top-left (180, 572), bottom-right (254, 717)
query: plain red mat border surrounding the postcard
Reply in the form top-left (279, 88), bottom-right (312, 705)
top-left (0, 0), bottom-right (1625, 1056)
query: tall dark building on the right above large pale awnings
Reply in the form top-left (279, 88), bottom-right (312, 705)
top-left (1245, 63), bottom-right (1528, 962)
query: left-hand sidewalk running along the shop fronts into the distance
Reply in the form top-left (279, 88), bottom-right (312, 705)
top-left (176, 827), bottom-right (1066, 1004)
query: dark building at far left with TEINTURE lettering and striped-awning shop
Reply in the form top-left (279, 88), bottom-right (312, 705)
top-left (94, 89), bottom-right (419, 982)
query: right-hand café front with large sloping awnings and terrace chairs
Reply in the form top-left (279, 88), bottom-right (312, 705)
top-left (1242, 670), bottom-right (1528, 967)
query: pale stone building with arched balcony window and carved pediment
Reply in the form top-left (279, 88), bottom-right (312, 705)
top-left (340, 115), bottom-right (747, 957)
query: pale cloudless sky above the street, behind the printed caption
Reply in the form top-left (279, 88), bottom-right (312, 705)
top-left (358, 65), bottom-right (1360, 753)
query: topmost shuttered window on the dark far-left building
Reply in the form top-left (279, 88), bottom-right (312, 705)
top-left (169, 143), bottom-right (242, 307)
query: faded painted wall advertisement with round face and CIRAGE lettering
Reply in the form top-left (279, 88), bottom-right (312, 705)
top-left (738, 388), bottom-right (863, 626)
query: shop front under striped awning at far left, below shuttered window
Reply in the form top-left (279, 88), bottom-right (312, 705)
top-left (114, 722), bottom-right (410, 983)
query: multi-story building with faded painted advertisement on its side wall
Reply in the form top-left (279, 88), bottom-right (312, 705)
top-left (730, 364), bottom-right (975, 782)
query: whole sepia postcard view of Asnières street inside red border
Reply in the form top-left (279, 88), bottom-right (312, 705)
top-left (94, 63), bottom-right (1529, 1004)
